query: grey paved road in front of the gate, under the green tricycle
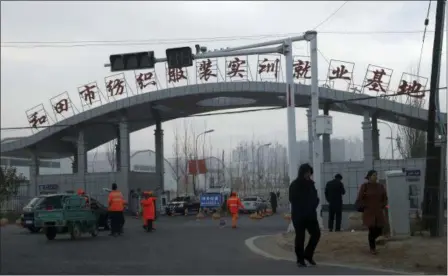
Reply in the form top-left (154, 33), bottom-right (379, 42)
top-left (1, 215), bottom-right (392, 275)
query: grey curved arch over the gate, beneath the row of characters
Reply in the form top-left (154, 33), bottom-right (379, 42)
top-left (0, 82), bottom-right (446, 159)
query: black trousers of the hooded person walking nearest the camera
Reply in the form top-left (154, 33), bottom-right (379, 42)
top-left (292, 217), bottom-right (320, 261)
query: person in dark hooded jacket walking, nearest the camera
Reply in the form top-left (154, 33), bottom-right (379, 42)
top-left (289, 164), bottom-right (320, 267)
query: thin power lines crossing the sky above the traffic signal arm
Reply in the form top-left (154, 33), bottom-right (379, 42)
top-left (1, 30), bottom-right (434, 49)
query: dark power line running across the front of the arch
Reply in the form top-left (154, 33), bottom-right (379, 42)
top-left (0, 86), bottom-right (447, 131)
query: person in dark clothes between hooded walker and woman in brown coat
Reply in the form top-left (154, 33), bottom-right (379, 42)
top-left (325, 174), bottom-right (345, 232)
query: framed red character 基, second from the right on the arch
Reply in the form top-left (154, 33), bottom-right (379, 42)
top-left (361, 64), bottom-right (393, 94)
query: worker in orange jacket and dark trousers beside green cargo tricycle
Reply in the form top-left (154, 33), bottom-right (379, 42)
top-left (108, 183), bottom-right (126, 237)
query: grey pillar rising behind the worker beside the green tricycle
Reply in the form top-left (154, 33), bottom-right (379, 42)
top-left (117, 116), bottom-right (131, 202)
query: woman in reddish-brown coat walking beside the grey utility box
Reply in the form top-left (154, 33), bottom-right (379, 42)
top-left (356, 170), bottom-right (387, 254)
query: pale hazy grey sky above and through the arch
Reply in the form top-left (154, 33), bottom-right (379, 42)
top-left (1, 1), bottom-right (446, 160)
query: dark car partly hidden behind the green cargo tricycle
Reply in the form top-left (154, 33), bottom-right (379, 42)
top-left (20, 194), bottom-right (110, 233)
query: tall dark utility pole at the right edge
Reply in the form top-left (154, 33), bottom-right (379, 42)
top-left (423, 0), bottom-right (446, 237)
